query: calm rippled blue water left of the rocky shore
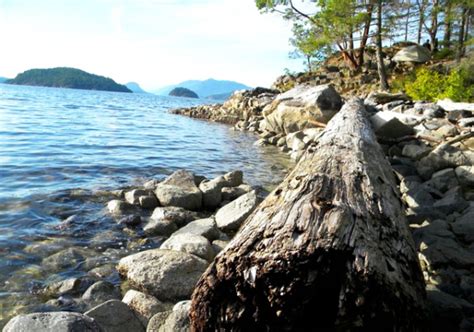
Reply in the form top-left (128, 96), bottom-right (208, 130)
top-left (0, 84), bottom-right (287, 327)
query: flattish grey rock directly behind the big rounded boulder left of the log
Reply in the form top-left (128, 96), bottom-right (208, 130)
top-left (160, 233), bottom-right (214, 261)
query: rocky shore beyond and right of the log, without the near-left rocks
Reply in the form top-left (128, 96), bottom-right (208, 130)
top-left (173, 84), bottom-right (474, 331)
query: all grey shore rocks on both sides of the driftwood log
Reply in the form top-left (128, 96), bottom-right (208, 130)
top-left (4, 81), bottom-right (474, 331)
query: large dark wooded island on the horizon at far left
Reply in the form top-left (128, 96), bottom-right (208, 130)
top-left (5, 67), bottom-right (132, 92)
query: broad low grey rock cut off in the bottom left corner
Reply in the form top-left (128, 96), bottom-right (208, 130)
top-left (3, 311), bottom-right (103, 332)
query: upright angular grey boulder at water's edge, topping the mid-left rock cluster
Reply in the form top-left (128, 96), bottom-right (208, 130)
top-left (155, 170), bottom-right (202, 210)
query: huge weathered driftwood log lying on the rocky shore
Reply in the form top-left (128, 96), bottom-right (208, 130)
top-left (190, 100), bottom-right (425, 331)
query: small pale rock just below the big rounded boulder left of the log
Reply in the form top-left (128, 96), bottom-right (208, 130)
top-left (122, 289), bottom-right (171, 326)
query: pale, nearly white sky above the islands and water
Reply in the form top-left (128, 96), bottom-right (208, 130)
top-left (0, 0), bottom-right (302, 90)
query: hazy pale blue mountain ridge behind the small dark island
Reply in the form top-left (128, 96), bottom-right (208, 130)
top-left (155, 78), bottom-right (250, 98)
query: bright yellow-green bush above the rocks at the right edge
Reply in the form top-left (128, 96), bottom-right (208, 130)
top-left (405, 68), bottom-right (474, 101)
